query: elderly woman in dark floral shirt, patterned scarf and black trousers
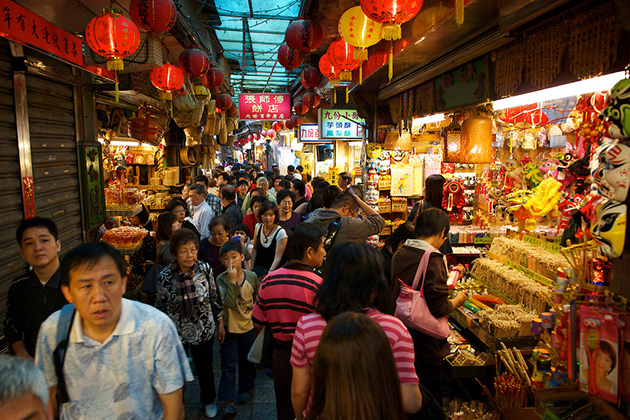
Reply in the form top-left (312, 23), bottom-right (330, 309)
top-left (155, 228), bottom-right (225, 418)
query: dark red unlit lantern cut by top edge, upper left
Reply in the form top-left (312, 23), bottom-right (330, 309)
top-left (129, 0), bottom-right (177, 34)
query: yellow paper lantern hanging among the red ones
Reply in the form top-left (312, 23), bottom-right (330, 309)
top-left (337, 6), bottom-right (383, 62)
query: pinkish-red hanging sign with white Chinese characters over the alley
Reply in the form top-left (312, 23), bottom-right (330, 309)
top-left (238, 93), bottom-right (291, 121)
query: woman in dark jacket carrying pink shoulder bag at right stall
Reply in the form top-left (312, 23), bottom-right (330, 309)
top-left (392, 208), bottom-right (466, 403)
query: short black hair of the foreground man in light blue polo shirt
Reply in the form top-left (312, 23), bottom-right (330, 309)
top-left (61, 242), bottom-right (127, 287)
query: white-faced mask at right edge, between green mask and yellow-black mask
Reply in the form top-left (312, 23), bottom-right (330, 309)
top-left (593, 141), bottom-right (630, 202)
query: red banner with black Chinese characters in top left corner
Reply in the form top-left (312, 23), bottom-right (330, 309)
top-left (0, 0), bottom-right (83, 66)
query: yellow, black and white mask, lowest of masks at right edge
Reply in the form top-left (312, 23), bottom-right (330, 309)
top-left (591, 201), bottom-right (627, 258)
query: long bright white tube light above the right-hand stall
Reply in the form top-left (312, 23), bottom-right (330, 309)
top-left (492, 71), bottom-right (625, 111)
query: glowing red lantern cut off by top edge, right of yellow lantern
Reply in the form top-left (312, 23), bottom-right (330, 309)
top-left (361, 0), bottom-right (424, 41)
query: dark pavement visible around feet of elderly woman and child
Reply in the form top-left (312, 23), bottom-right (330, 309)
top-left (184, 342), bottom-right (277, 420)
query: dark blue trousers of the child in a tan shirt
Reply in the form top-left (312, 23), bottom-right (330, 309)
top-left (219, 328), bottom-right (256, 402)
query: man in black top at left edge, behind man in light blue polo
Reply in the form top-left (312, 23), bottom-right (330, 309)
top-left (4, 217), bottom-right (67, 361)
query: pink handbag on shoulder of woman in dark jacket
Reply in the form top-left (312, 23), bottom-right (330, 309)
top-left (394, 247), bottom-right (451, 339)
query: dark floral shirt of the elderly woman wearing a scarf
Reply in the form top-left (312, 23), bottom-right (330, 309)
top-left (155, 260), bottom-right (223, 344)
